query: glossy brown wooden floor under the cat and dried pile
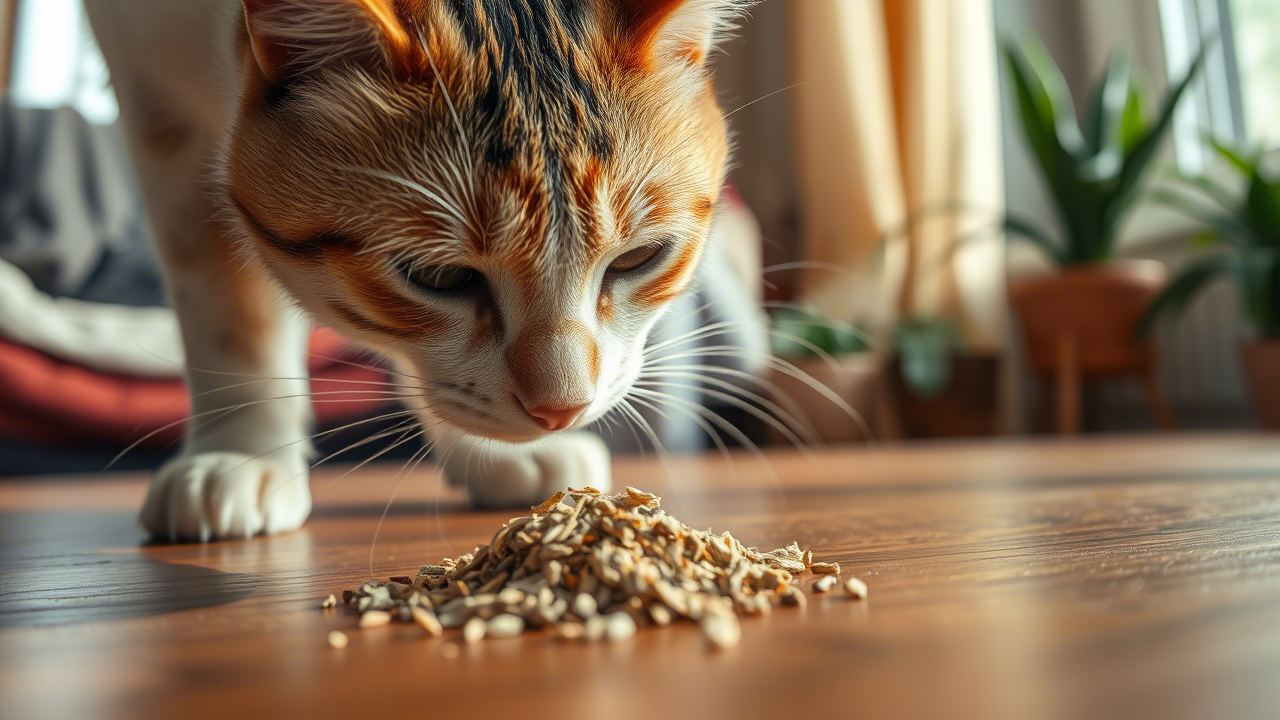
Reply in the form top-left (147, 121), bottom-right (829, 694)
top-left (0, 436), bottom-right (1280, 720)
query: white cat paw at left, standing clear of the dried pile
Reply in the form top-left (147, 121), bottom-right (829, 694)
top-left (138, 452), bottom-right (311, 542)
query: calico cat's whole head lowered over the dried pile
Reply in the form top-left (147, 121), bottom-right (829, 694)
top-left (225, 0), bottom-right (749, 441)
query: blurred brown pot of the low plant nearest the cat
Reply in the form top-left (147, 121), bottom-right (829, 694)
top-left (769, 352), bottom-right (881, 445)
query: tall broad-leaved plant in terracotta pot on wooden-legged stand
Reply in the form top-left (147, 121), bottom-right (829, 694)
top-left (1002, 44), bottom-right (1204, 432)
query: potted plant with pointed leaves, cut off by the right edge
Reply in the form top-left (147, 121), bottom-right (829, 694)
top-left (1140, 142), bottom-right (1280, 429)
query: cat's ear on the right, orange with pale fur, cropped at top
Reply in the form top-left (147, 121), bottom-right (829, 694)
top-left (612, 0), bottom-right (758, 67)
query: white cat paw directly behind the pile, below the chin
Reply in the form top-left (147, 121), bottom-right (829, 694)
top-left (443, 433), bottom-right (613, 509)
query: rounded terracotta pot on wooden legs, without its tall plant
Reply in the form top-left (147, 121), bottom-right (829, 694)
top-left (1009, 260), bottom-right (1167, 375)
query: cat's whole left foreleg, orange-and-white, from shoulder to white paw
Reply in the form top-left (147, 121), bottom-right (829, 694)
top-left (86, 0), bottom-right (311, 541)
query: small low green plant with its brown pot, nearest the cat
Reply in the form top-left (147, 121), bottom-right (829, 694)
top-left (771, 306), bottom-right (881, 443)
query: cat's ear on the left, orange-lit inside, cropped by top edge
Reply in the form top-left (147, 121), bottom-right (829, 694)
top-left (243, 0), bottom-right (413, 85)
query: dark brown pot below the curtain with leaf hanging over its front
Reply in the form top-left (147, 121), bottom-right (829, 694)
top-left (882, 352), bottom-right (1000, 438)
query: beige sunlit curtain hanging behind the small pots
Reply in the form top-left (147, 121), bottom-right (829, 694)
top-left (790, 0), bottom-right (1005, 346)
